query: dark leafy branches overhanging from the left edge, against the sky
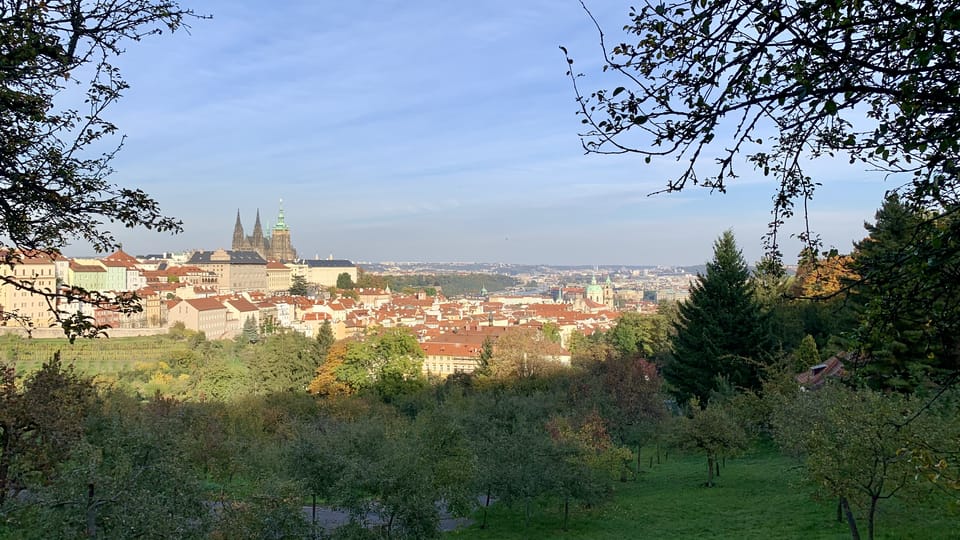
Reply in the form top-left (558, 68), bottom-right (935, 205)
top-left (0, 0), bottom-right (201, 339)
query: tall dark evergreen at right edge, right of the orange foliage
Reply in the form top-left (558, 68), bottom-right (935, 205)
top-left (852, 195), bottom-right (960, 391)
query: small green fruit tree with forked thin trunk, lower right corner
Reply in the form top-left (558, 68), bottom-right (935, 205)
top-left (771, 384), bottom-right (957, 539)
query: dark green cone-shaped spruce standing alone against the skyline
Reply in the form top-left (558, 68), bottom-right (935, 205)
top-left (663, 231), bottom-right (771, 405)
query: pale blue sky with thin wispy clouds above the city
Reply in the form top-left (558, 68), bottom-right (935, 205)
top-left (77, 0), bottom-right (892, 264)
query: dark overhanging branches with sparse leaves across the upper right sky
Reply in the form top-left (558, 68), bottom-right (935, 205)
top-left (564, 0), bottom-right (960, 253)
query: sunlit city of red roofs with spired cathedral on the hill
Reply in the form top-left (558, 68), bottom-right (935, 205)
top-left (0, 206), bottom-right (788, 375)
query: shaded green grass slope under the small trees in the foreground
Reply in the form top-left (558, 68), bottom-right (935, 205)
top-left (449, 449), bottom-right (960, 540)
